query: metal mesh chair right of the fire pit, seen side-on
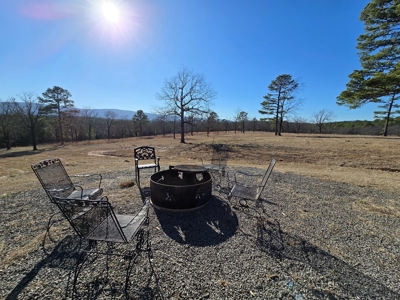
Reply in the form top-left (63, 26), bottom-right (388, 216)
top-left (228, 159), bottom-right (276, 206)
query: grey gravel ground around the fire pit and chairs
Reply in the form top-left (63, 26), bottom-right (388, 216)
top-left (0, 169), bottom-right (400, 300)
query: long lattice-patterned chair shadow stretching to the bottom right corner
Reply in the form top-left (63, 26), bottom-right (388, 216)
top-left (256, 220), bottom-right (400, 299)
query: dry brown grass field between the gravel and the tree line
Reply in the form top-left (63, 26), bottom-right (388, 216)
top-left (0, 132), bottom-right (400, 195)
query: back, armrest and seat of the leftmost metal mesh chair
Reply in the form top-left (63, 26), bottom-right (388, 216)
top-left (31, 158), bottom-right (103, 201)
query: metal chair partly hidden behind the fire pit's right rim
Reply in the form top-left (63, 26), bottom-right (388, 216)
top-left (202, 144), bottom-right (229, 186)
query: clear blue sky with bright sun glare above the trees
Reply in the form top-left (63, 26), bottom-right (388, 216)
top-left (0, 0), bottom-right (376, 121)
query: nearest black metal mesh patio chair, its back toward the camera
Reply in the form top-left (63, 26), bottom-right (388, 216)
top-left (53, 196), bottom-right (150, 292)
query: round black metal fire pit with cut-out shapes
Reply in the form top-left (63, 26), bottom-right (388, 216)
top-left (150, 165), bottom-right (212, 211)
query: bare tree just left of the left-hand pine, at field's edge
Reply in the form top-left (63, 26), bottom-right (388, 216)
top-left (15, 92), bottom-right (42, 150)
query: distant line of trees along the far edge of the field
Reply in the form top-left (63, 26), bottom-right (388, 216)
top-left (0, 87), bottom-right (400, 150)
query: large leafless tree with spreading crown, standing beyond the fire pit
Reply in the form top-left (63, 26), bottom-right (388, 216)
top-left (157, 67), bottom-right (216, 143)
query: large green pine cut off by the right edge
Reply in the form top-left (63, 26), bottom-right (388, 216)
top-left (337, 0), bottom-right (400, 136)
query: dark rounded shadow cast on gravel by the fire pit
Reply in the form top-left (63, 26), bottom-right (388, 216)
top-left (154, 196), bottom-right (239, 247)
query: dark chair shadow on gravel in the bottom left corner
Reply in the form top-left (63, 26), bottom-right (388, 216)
top-left (5, 235), bottom-right (79, 300)
